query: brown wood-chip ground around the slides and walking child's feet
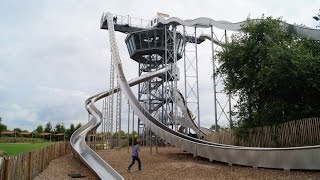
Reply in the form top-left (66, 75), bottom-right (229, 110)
top-left (35, 147), bottom-right (320, 180)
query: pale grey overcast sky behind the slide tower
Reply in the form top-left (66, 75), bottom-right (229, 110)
top-left (0, 0), bottom-right (320, 131)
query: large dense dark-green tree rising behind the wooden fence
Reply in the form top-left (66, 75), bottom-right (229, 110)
top-left (218, 17), bottom-right (320, 128)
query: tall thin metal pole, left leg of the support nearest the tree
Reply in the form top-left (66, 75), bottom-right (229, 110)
top-left (211, 26), bottom-right (218, 132)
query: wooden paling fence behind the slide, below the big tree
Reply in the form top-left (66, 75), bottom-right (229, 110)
top-left (207, 118), bottom-right (320, 147)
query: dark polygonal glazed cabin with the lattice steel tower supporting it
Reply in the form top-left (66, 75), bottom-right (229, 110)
top-left (126, 19), bottom-right (184, 136)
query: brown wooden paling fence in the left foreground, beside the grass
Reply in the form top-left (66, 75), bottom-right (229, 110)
top-left (0, 142), bottom-right (71, 180)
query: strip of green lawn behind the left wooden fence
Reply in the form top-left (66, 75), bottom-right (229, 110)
top-left (0, 142), bottom-right (52, 156)
